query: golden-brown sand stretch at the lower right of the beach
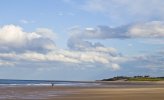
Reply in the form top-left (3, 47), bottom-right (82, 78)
top-left (55, 88), bottom-right (164, 100)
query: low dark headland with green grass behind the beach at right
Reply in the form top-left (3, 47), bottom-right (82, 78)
top-left (101, 75), bottom-right (164, 81)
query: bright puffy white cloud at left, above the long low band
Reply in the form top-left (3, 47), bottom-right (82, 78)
top-left (0, 25), bottom-right (55, 51)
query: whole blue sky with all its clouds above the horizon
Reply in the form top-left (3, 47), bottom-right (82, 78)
top-left (0, 0), bottom-right (164, 80)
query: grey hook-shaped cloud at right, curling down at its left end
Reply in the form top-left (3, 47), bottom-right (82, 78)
top-left (67, 21), bottom-right (164, 54)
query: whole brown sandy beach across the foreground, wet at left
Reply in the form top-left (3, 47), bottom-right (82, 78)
top-left (0, 82), bottom-right (164, 100)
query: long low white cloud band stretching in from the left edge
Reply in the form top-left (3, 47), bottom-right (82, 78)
top-left (0, 48), bottom-right (124, 70)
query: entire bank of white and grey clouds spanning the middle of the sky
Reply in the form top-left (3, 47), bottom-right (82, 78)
top-left (0, 21), bottom-right (164, 70)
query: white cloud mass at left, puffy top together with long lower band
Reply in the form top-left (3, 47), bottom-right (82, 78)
top-left (0, 25), bottom-right (125, 70)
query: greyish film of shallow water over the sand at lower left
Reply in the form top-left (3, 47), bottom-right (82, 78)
top-left (0, 87), bottom-right (75, 100)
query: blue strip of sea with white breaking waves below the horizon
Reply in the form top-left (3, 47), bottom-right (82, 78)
top-left (0, 79), bottom-right (99, 87)
